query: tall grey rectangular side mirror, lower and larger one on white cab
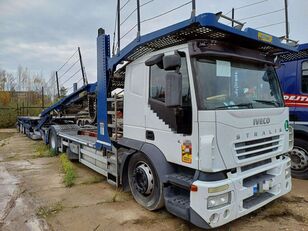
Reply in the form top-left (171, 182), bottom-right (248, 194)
top-left (165, 72), bottom-right (182, 107)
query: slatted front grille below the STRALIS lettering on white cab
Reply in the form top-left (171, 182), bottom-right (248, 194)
top-left (235, 135), bottom-right (282, 160)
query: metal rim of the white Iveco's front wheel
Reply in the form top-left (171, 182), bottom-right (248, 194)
top-left (133, 162), bottom-right (154, 196)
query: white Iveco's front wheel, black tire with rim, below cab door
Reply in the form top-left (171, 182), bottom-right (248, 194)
top-left (128, 152), bottom-right (164, 210)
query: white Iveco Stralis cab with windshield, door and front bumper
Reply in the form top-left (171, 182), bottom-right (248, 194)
top-left (123, 40), bottom-right (291, 227)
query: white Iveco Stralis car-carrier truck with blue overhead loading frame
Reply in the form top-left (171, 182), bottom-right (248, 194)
top-left (17, 7), bottom-right (296, 228)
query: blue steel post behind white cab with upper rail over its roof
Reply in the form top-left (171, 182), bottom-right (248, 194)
top-left (96, 13), bottom-right (297, 149)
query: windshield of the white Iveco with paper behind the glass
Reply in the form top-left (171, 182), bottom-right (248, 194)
top-left (193, 58), bottom-right (283, 110)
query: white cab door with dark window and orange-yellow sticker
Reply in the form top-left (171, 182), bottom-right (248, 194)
top-left (145, 49), bottom-right (198, 169)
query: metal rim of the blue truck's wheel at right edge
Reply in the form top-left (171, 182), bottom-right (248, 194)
top-left (290, 146), bottom-right (308, 170)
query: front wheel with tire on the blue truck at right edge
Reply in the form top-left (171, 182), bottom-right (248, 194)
top-left (289, 138), bottom-right (308, 180)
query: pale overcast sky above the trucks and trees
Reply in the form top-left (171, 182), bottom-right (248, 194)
top-left (0, 0), bottom-right (308, 88)
